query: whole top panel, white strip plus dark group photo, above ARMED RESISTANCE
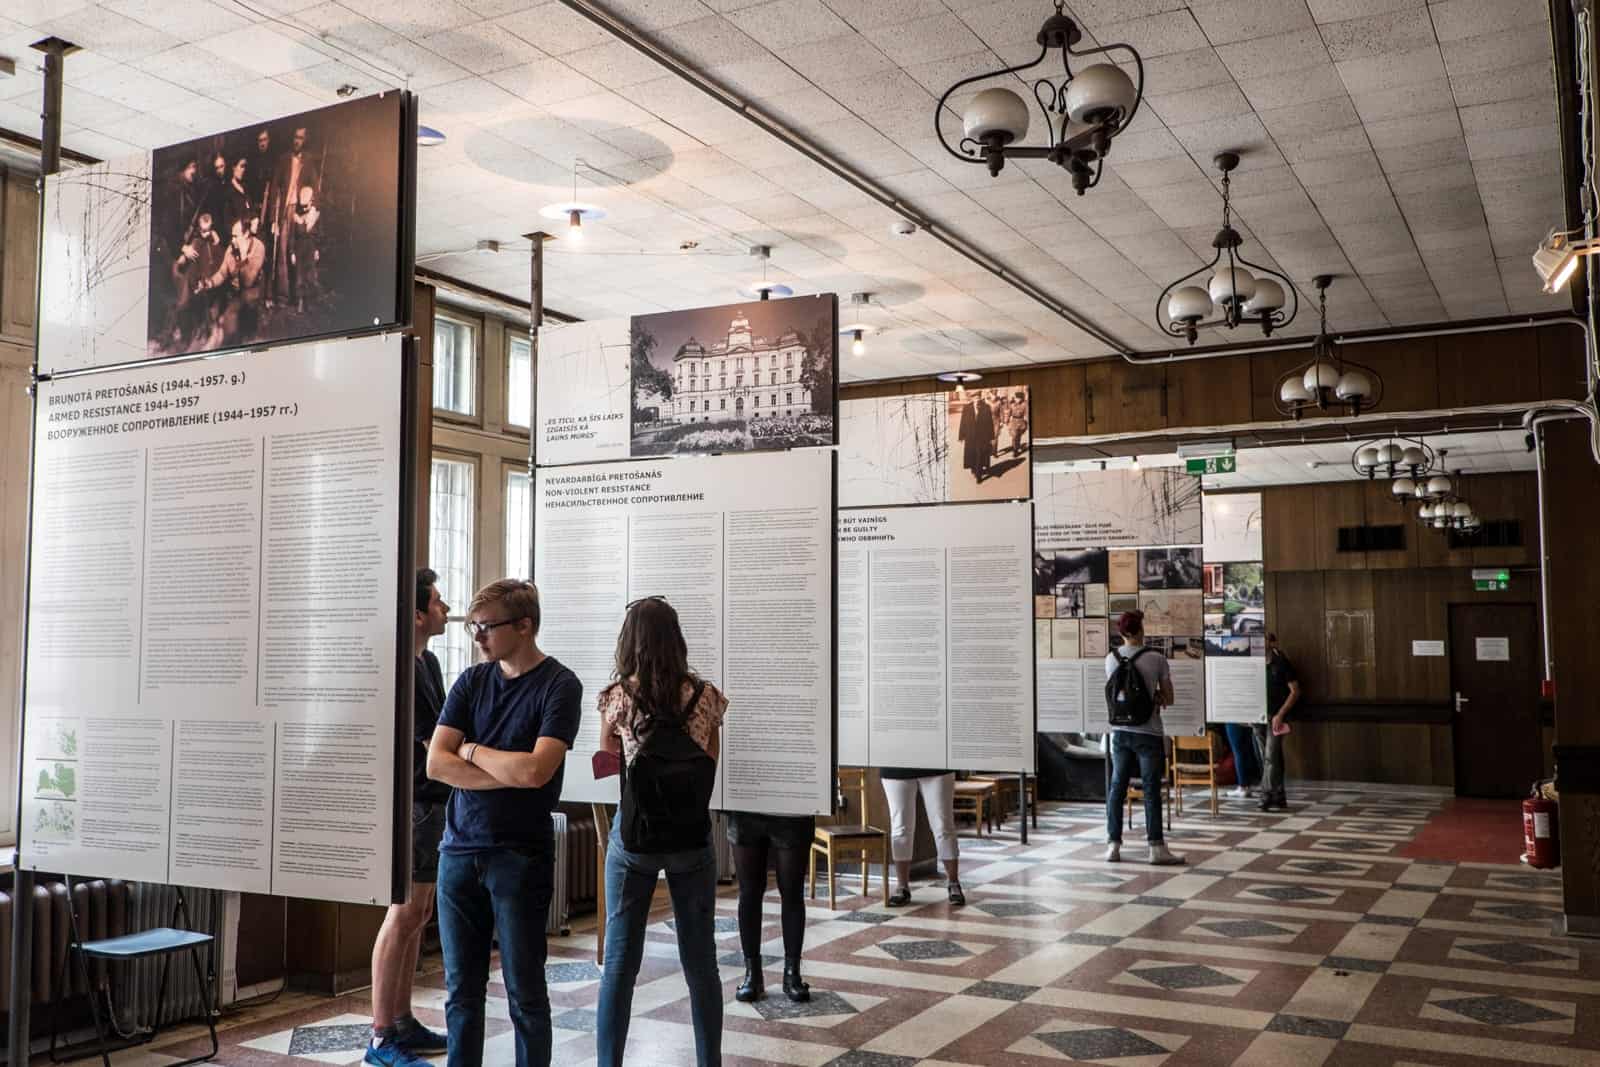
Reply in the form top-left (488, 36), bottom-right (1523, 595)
top-left (38, 91), bottom-right (416, 374)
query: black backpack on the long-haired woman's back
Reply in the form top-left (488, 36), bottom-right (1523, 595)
top-left (618, 681), bottom-right (717, 853)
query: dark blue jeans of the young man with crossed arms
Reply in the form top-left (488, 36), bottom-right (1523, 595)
top-left (438, 849), bottom-right (555, 1067)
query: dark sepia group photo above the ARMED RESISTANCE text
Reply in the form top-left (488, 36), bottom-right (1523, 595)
top-left (147, 93), bottom-right (405, 355)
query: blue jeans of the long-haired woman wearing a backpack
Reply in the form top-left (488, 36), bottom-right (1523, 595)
top-left (598, 825), bottom-right (722, 1067)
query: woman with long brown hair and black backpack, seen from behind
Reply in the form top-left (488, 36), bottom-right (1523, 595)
top-left (595, 597), bottom-right (728, 1067)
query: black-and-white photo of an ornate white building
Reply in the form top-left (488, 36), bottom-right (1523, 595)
top-left (630, 294), bottom-right (838, 456)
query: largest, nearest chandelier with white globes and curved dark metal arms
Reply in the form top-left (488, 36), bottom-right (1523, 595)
top-left (933, 0), bottom-right (1144, 197)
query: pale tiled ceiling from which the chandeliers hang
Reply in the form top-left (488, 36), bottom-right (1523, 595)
top-left (0, 0), bottom-right (1565, 381)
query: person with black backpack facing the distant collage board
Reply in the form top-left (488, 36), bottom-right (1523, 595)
top-left (1106, 611), bottom-right (1184, 867)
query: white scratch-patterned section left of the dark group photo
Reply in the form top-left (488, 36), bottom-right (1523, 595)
top-left (38, 152), bottom-right (150, 374)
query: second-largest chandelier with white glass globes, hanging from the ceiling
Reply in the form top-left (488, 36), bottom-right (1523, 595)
top-left (1155, 152), bottom-right (1299, 344)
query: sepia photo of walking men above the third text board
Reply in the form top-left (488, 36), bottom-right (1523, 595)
top-left (946, 389), bottom-right (1034, 501)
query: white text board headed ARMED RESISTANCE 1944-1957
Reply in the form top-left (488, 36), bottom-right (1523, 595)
top-left (21, 336), bottom-right (410, 904)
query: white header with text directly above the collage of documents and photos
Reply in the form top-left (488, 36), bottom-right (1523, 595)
top-left (1034, 467), bottom-right (1203, 547)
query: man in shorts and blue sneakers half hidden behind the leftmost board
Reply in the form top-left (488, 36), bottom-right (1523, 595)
top-left (365, 566), bottom-right (450, 1067)
